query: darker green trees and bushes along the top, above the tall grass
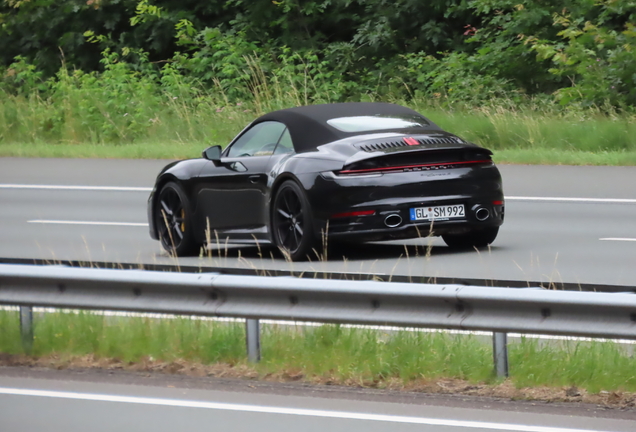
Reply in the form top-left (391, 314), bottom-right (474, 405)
top-left (0, 0), bottom-right (636, 110)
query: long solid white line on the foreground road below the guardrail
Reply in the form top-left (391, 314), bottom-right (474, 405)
top-left (0, 387), bottom-right (602, 432)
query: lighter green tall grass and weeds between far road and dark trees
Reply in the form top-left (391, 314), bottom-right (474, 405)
top-left (0, 49), bottom-right (636, 160)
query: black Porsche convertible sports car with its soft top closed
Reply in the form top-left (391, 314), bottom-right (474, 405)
top-left (148, 103), bottom-right (504, 260)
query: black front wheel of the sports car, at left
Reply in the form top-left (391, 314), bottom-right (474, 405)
top-left (154, 182), bottom-right (199, 256)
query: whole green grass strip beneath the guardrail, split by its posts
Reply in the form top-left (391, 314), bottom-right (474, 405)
top-left (0, 311), bottom-right (636, 392)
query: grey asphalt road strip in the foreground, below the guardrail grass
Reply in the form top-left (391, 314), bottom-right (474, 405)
top-left (0, 368), bottom-right (636, 432)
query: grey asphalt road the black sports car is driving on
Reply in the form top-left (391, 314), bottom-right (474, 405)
top-left (0, 158), bottom-right (636, 286)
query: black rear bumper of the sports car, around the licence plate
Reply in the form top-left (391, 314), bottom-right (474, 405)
top-left (300, 165), bottom-right (504, 241)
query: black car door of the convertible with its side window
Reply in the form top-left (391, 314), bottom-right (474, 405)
top-left (195, 121), bottom-right (286, 241)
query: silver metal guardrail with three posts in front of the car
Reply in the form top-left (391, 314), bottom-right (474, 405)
top-left (0, 265), bottom-right (636, 376)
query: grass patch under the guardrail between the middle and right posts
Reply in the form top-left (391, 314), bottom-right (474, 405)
top-left (261, 325), bottom-right (492, 384)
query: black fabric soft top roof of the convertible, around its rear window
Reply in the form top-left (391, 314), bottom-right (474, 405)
top-left (254, 102), bottom-right (437, 153)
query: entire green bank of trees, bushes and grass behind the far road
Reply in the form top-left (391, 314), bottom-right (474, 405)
top-left (0, 0), bottom-right (636, 152)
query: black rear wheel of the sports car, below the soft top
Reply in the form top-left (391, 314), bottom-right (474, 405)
top-left (272, 180), bottom-right (315, 261)
